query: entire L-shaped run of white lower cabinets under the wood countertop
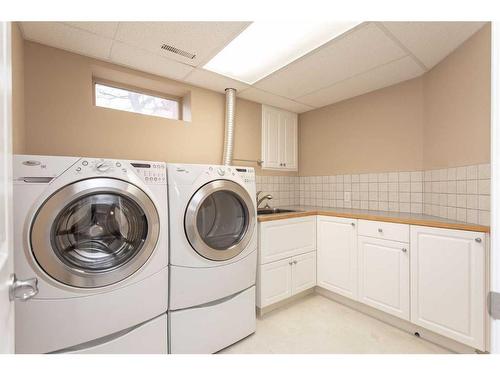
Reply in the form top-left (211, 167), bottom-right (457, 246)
top-left (257, 216), bottom-right (487, 351)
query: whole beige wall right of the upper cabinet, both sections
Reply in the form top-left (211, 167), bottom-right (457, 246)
top-left (299, 25), bottom-right (490, 176)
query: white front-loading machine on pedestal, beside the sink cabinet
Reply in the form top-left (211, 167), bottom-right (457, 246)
top-left (167, 164), bottom-right (257, 354)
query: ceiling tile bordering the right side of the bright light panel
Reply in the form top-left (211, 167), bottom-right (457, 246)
top-left (255, 23), bottom-right (406, 99)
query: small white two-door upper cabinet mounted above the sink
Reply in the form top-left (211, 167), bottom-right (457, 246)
top-left (262, 105), bottom-right (298, 171)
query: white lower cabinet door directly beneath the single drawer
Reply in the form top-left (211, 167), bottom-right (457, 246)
top-left (358, 236), bottom-right (410, 320)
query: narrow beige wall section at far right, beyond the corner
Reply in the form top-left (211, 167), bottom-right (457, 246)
top-left (424, 24), bottom-right (491, 169)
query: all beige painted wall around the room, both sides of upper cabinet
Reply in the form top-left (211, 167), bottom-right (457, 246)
top-left (13, 25), bottom-right (490, 175)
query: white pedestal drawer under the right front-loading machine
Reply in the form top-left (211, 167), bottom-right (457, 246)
top-left (169, 286), bottom-right (256, 354)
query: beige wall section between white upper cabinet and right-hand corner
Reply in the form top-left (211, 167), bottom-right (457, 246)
top-left (299, 78), bottom-right (423, 176)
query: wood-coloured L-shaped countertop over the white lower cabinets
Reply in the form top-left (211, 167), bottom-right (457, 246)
top-left (257, 206), bottom-right (490, 233)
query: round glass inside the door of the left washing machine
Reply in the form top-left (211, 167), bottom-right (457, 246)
top-left (51, 193), bottom-right (148, 271)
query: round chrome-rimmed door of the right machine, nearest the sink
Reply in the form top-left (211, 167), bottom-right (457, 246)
top-left (184, 180), bottom-right (256, 261)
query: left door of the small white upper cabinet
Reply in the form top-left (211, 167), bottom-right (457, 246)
top-left (262, 106), bottom-right (282, 169)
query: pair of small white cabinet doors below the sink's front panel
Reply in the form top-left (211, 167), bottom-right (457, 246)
top-left (257, 251), bottom-right (316, 308)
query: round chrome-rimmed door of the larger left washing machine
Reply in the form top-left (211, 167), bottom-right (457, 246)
top-left (30, 178), bottom-right (160, 288)
